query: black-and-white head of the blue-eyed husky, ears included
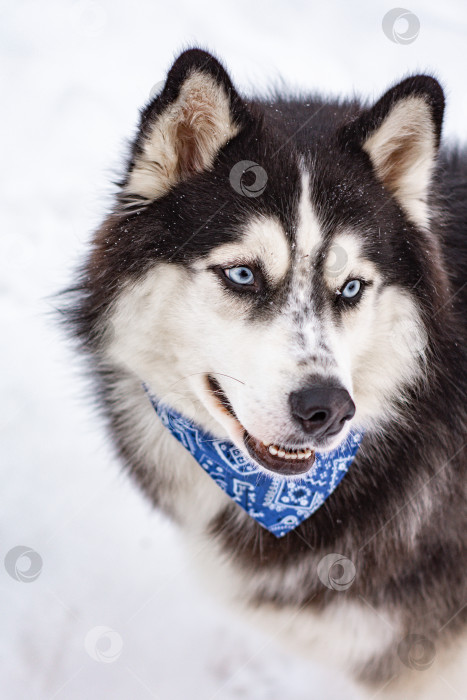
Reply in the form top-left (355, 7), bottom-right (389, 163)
top-left (89, 50), bottom-right (445, 474)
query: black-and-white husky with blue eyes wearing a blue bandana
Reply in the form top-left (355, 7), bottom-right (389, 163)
top-left (65, 48), bottom-right (467, 700)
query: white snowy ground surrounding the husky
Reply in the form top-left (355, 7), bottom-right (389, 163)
top-left (0, 0), bottom-right (467, 700)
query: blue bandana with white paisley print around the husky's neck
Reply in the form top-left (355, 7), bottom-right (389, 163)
top-left (143, 384), bottom-right (363, 537)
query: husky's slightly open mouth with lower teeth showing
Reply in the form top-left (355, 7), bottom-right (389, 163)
top-left (206, 374), bottom-right (315, 476)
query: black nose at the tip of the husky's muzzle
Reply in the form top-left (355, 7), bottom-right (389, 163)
top-left (289, 380), bottom-right (355, 438)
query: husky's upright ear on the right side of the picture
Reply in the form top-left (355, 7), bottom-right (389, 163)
top-left (342, 75), bottom-right (444, 227)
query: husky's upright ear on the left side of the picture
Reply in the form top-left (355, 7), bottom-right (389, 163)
top-left (122, 49), bottom-right (249, 203)
